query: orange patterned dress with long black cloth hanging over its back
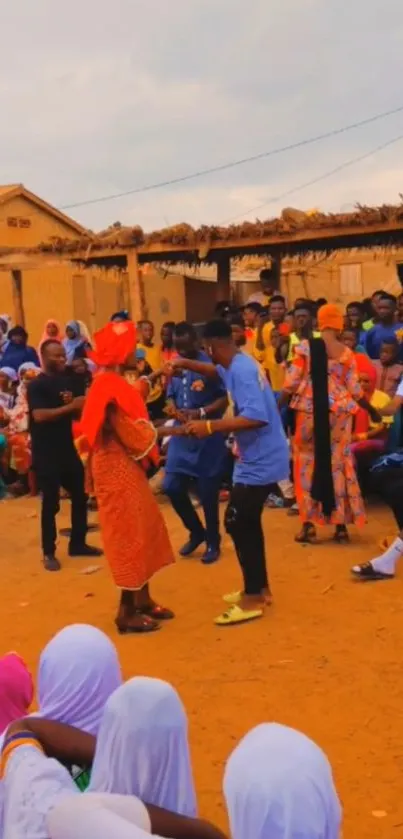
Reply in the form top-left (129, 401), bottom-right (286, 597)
top-left (284, 341), bottom-right (365, 525)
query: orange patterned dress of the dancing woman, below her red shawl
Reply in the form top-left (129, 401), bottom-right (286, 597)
top-left (88, 409), bottom-right (175, 591)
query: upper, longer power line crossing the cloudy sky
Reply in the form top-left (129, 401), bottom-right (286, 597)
top-left (59, 105), bottom-right (403, 210)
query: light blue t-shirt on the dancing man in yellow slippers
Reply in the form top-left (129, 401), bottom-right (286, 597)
top-left (217, 352), bottom-right (290, 486)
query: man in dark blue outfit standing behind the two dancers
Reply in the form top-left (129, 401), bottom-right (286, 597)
top-left (163, 322), bottom-right (227, 564)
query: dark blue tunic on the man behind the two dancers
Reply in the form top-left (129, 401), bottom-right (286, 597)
top-left (165, 352), bottom-right (227, 478)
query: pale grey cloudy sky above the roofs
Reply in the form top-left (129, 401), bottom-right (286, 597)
top-left (0, 0), bottom-right (403, 230)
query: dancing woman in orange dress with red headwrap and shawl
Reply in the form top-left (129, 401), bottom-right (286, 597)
top-left (77, 321), bottom-right (174, 633)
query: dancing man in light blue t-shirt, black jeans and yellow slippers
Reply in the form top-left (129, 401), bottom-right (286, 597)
top-left (178, 320), bottom-right (289, 626)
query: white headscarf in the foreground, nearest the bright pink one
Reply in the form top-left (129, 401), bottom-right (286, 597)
top-left (35, 624), bottom-right (122, 736)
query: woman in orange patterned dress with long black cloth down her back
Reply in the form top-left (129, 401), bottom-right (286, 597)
top-left (284, 304), bottom-right (378, 542)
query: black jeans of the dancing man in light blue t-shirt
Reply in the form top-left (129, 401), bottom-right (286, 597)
top-left (224, 484), bottom-right (270, 594)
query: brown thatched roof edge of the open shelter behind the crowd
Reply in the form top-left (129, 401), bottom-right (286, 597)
top-left (3, 201), bottom-right (403, 262)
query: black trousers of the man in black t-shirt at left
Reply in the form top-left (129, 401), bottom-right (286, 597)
top-left (37, 458), bottom-right (87, 556)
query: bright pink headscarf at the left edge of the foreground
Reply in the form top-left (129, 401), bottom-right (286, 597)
top-left (0, 653), bottom-right (34, 734)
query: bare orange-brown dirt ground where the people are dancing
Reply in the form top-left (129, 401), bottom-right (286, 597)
top-left (0, 499), bottom-right (403, 839)
